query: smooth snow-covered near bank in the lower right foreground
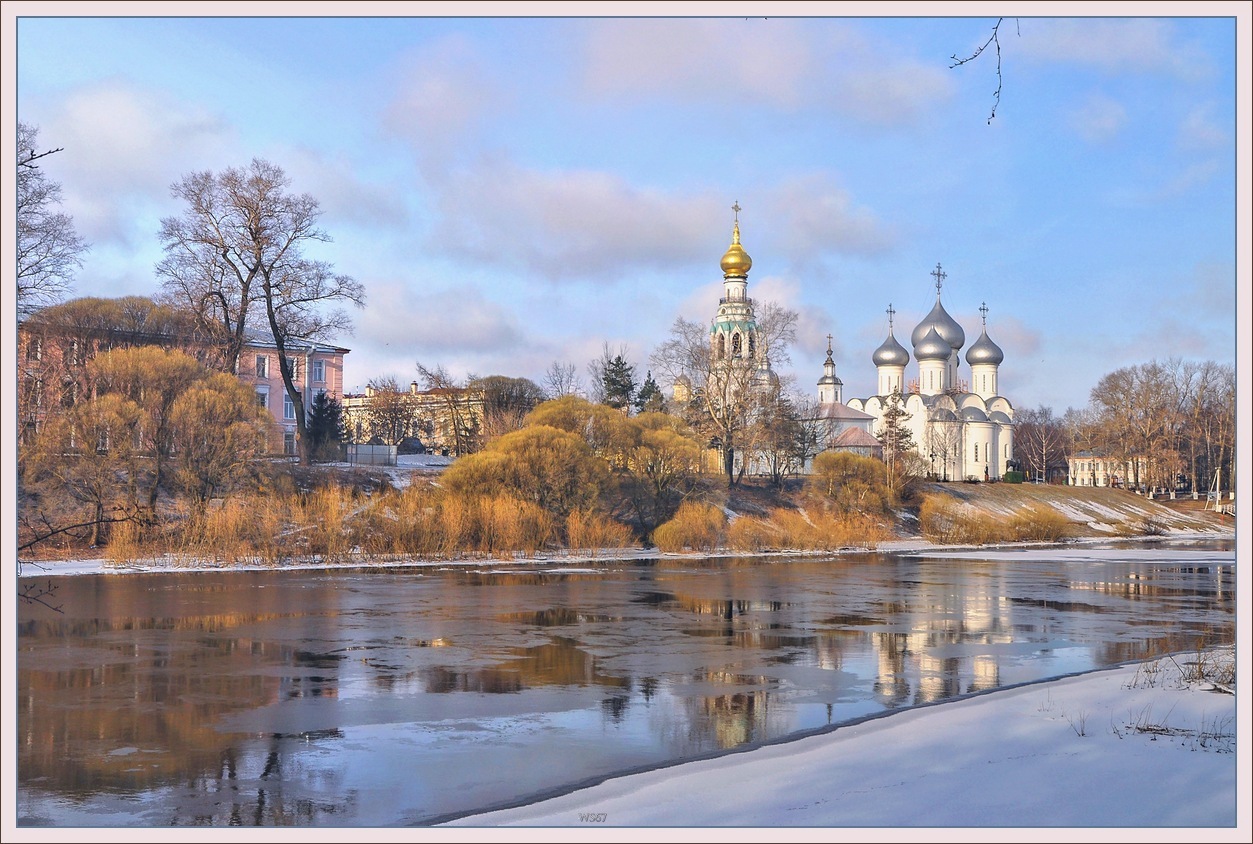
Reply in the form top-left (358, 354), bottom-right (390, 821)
top-left (450, 652), bottom-right (1249, 841)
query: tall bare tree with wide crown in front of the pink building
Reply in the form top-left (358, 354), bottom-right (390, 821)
top-left (157, 159), bottom-right (365, 462)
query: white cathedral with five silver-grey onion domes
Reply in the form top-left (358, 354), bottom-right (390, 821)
top-left (847, 264), bottom-right (1014, 481)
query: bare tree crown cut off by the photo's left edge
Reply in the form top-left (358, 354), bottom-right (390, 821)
top-left (16, 123), bottom-right (88, 317)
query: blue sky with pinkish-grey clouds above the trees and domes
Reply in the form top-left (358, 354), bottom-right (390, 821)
top-left (5, 3), bottom-right (1248, 414)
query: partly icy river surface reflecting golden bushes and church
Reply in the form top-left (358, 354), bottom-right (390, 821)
top-left (18, 545), bottom-right (1235, 825)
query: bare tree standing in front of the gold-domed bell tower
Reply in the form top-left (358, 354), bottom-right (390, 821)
top-left (650, 303), bottom-right (797, 486)
